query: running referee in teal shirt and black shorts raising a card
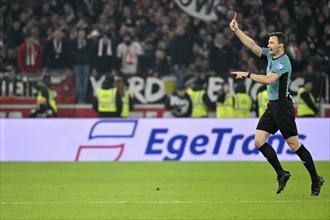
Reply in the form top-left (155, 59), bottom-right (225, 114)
top-left (230, 18), bottom-right (324, 196)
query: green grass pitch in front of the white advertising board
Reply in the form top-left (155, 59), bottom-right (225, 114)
top-left (0, 162), bottom-right (330, 220)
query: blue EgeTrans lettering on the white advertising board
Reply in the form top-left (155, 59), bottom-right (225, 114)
top-left (145, 128), bottom-right (306, 160)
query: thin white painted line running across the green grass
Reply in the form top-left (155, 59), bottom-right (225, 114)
top-left (0, 200), bottom-right (330, 205)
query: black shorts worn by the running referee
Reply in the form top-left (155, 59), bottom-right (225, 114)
top-left (257, 99), bottom-right (298, 139)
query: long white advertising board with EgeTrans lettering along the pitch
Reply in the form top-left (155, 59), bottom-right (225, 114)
top-left (0, 118), bottom-right (330, 161)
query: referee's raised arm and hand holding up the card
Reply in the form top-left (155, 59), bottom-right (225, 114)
top-left (229, 19), bottom-right (262, 57)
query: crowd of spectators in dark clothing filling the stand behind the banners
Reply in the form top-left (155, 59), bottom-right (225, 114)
top-left (0, 0), bottom-right (330, 102)
